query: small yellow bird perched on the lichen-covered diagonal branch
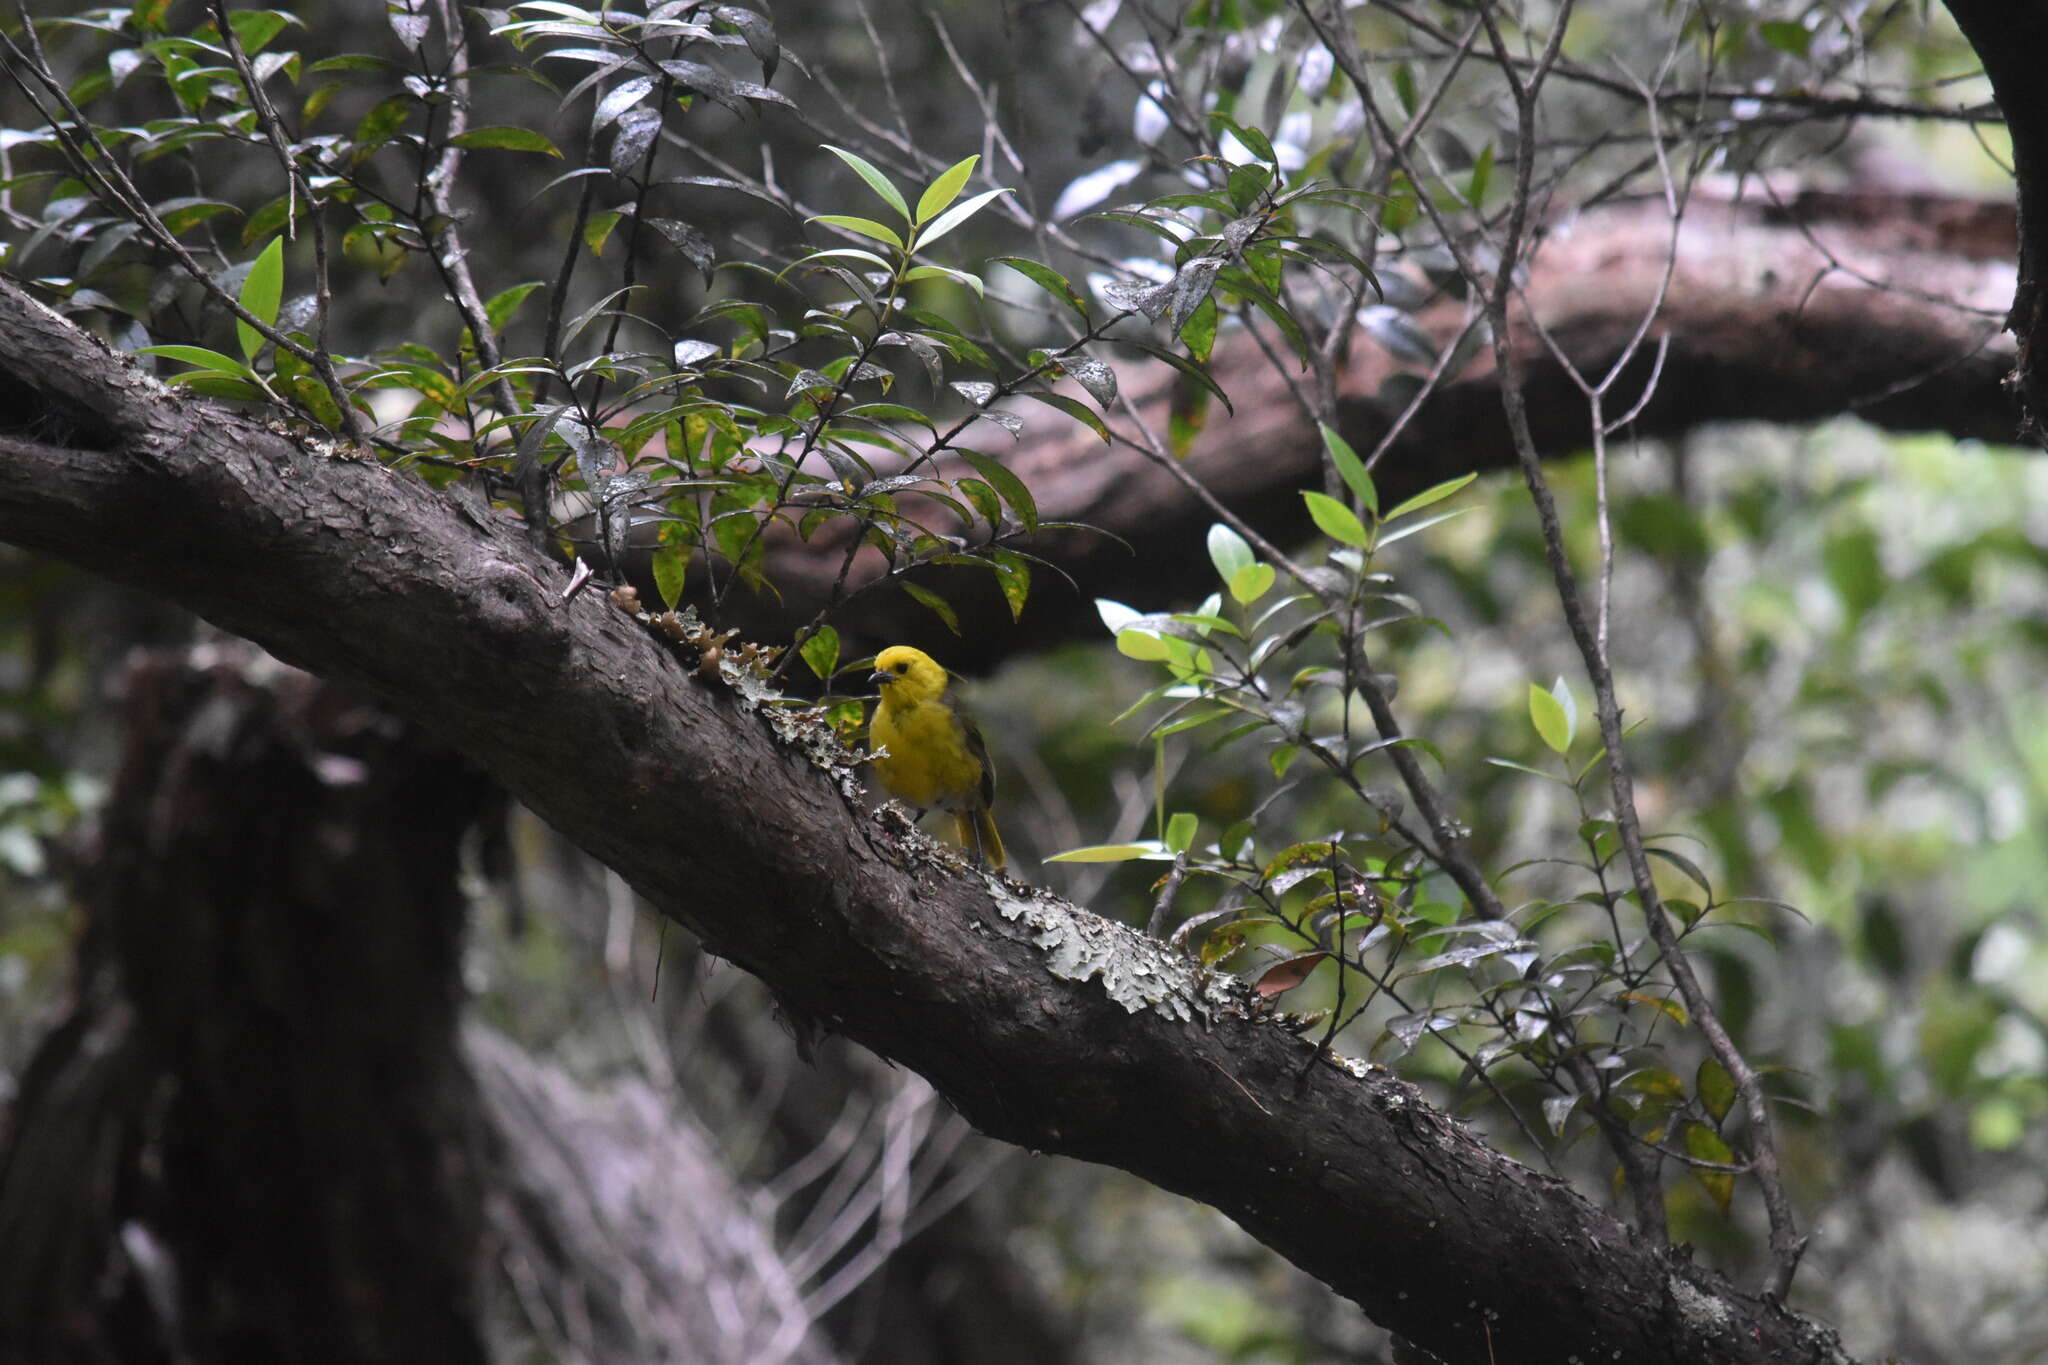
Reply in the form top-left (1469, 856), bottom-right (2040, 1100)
top-left (868, 645), bottom-right (1006, 868)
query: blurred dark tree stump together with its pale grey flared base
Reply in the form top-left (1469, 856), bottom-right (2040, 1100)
top-left (0, 643), bottom-right (860, 1365)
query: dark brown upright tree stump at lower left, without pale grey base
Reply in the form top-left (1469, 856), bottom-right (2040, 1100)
top-left (0, 645), bottom-right (492, 1363)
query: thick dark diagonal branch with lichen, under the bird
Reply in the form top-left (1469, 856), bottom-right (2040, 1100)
top-left (0, 284), bottom-right (1845, 1365)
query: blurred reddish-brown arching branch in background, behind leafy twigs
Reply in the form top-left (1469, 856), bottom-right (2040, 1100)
top-left (725, 182), bottom-right (2019, 667)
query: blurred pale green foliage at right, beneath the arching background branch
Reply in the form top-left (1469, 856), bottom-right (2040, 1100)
top-left (983, 422), bottom-right (2048, 1361)
